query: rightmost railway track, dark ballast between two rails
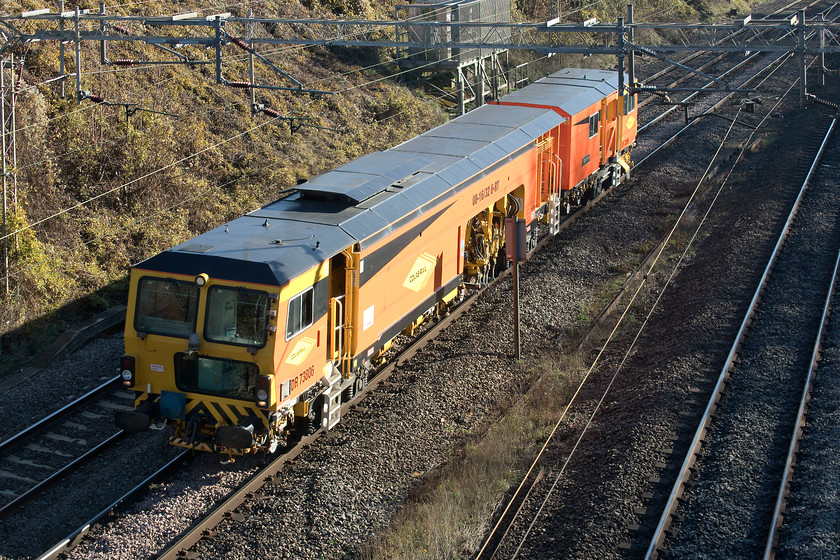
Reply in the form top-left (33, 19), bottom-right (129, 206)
top-left (645, 117), bottom-right (840, 558)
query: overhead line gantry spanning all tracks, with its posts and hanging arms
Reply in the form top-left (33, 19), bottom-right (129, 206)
top-left (0, 3), bottom-right (840, 106)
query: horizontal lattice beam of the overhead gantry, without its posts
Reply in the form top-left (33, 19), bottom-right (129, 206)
top-left (0, 7), bottom-right (840, 58)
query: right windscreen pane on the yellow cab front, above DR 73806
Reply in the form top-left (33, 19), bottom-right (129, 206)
top-left (204, 286), bottom-right (269, 347)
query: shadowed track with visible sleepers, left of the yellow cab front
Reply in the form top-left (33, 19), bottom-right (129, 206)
top-left (0, 377), bottom-right (134, 519)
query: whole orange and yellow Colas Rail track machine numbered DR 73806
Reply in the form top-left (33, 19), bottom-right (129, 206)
top-left (113, 69), bottom-right (636, 454)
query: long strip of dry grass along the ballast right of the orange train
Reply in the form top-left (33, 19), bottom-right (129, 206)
top-left (357, 200), bottom-right (708, 560)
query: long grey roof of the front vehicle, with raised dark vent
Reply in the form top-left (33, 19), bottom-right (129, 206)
top-left (137, 98), bottom-right (565, 286)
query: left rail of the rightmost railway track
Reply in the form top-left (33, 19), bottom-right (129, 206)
top-left (645, 114), bottom-right (833, 560)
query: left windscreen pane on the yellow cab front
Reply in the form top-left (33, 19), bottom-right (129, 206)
top-left (134, 277), bottom-right (198, 338)
